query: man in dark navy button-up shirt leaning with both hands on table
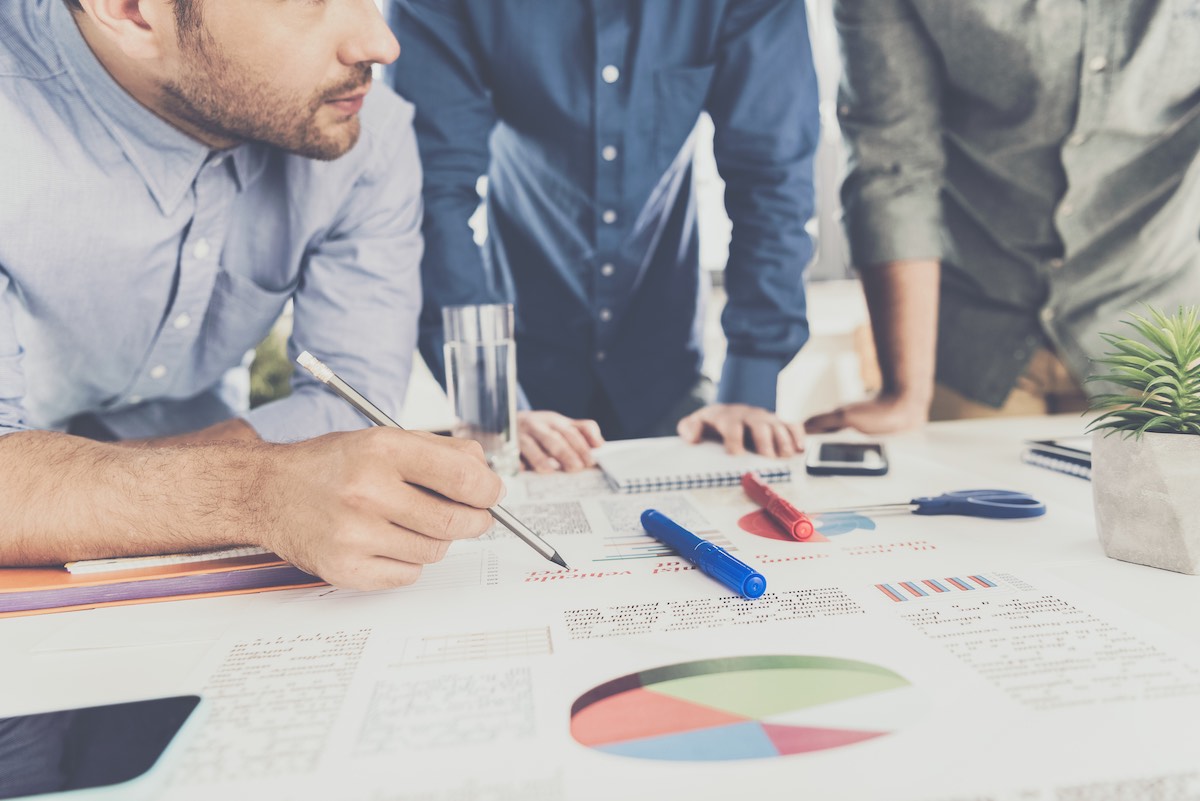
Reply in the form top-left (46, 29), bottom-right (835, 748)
top-left (391, 0), bottom-right (818, 470)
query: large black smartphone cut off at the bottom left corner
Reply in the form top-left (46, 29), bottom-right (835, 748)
top-left (0, 695), bottom-right (200, 799)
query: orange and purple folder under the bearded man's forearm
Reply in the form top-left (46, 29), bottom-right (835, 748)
top-left (0, 554), bottom-right (325, 618)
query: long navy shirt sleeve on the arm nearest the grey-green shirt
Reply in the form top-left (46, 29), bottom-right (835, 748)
top-left (706, 0), bottom-right (820, 409)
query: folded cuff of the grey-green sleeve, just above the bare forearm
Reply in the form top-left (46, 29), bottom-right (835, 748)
top-left (846, 193), bottom-right (943, 269)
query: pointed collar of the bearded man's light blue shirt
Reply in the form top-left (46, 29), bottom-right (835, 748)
top-left (49, 1), bottom-right (264, 215)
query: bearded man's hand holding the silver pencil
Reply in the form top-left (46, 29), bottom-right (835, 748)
top-left (260, 428), bottom-right (504, 590)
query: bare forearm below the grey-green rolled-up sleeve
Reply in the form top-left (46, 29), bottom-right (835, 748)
top-left (862, 260), bottom-right (941, 404)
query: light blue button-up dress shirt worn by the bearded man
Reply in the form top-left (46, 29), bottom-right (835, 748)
top-left (0, 0), bottom-right (422, 441)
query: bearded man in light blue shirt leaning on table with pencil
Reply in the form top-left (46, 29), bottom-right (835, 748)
top-left (0, 0), bottom-right (502, 588)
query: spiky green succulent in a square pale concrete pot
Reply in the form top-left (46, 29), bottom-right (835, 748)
top-left (1087, 306), bottom-right (1200, 574)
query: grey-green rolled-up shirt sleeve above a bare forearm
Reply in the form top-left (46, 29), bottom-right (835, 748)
top-left (834, 0), bottom-right (946, 267)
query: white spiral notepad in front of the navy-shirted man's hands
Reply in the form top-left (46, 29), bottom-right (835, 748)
top-left (595, 436), bottom-right (792, 493)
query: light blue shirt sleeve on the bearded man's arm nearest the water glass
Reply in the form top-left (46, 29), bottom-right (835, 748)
top-left (245, 99), bottom-right (422, 441)
